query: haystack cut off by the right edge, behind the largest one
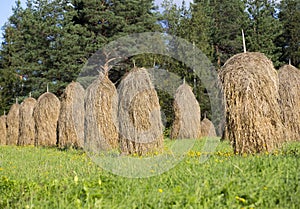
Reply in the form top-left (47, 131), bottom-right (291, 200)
top-left (279, 65), bottom-right (300, 141)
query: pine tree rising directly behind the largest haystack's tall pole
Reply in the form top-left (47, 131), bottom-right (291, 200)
top-left (196, 0), bottom-right (248, 68)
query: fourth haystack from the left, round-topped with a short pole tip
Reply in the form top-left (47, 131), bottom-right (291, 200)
top-left (33, 92), bottom-right (60, 146)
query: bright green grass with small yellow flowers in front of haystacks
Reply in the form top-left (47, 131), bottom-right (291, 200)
top-left (0, 142), bottom-right (300, 209)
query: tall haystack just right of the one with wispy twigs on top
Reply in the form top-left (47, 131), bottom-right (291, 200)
top-left (118, 68), bottom-right (163, 155)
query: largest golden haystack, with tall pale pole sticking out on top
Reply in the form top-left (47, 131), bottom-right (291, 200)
top-left (219, 52), bottom-right (285, 153)
